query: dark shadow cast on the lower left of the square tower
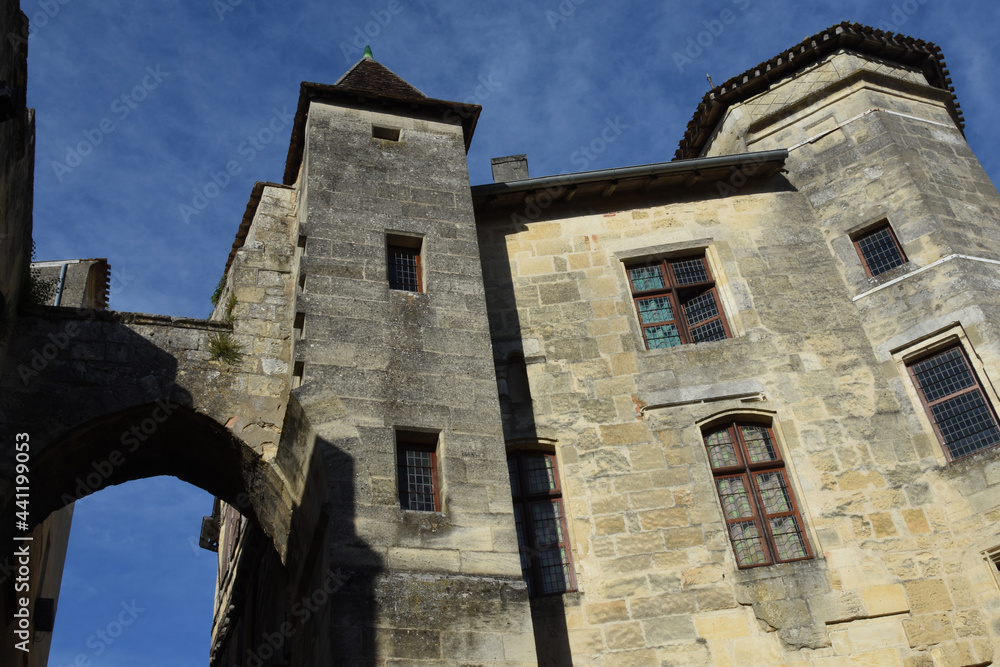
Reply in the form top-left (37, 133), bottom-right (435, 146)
top-left (211, 393), bottom-right (384, 667)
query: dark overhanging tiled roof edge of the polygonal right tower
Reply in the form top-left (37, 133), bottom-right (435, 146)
top-left (674, 21), bottom-right (965, 160)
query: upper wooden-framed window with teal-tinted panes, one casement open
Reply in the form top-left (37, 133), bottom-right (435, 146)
top-left (626, 253), bottom-right (731, 350)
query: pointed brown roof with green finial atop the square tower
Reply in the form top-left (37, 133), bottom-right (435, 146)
top-left (282, 54), bottom-right (482, 185)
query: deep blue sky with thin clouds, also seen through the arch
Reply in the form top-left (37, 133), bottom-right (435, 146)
top-left (21, 0), bottom-right (1000, 665)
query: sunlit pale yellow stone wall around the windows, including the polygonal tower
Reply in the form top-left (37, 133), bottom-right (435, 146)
top-left (480, 54), bottom-right (1000, 666)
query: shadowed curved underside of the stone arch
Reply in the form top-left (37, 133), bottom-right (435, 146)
top-left (0, 400), bottom-right (293, 560)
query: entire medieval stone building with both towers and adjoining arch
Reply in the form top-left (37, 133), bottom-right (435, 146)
top-left (0, 14), bottom-right (1000, 667)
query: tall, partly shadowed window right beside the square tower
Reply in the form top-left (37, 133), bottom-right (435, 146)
top-left (507, 451), bottom-right (576, 595)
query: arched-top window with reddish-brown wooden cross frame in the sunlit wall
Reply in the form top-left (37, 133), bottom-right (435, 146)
top-left (702, 422), bottom-right (812, 568)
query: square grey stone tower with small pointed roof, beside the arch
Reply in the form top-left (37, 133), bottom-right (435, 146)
top-left (205, 55), bottom-right (534, 665)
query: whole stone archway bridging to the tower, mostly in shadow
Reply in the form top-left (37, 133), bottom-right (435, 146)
top-left (0, 308), bottom-right (294, 560)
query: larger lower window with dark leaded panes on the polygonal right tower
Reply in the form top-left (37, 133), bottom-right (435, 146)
top-left (907, 343), bottom-right (1000, 460)
